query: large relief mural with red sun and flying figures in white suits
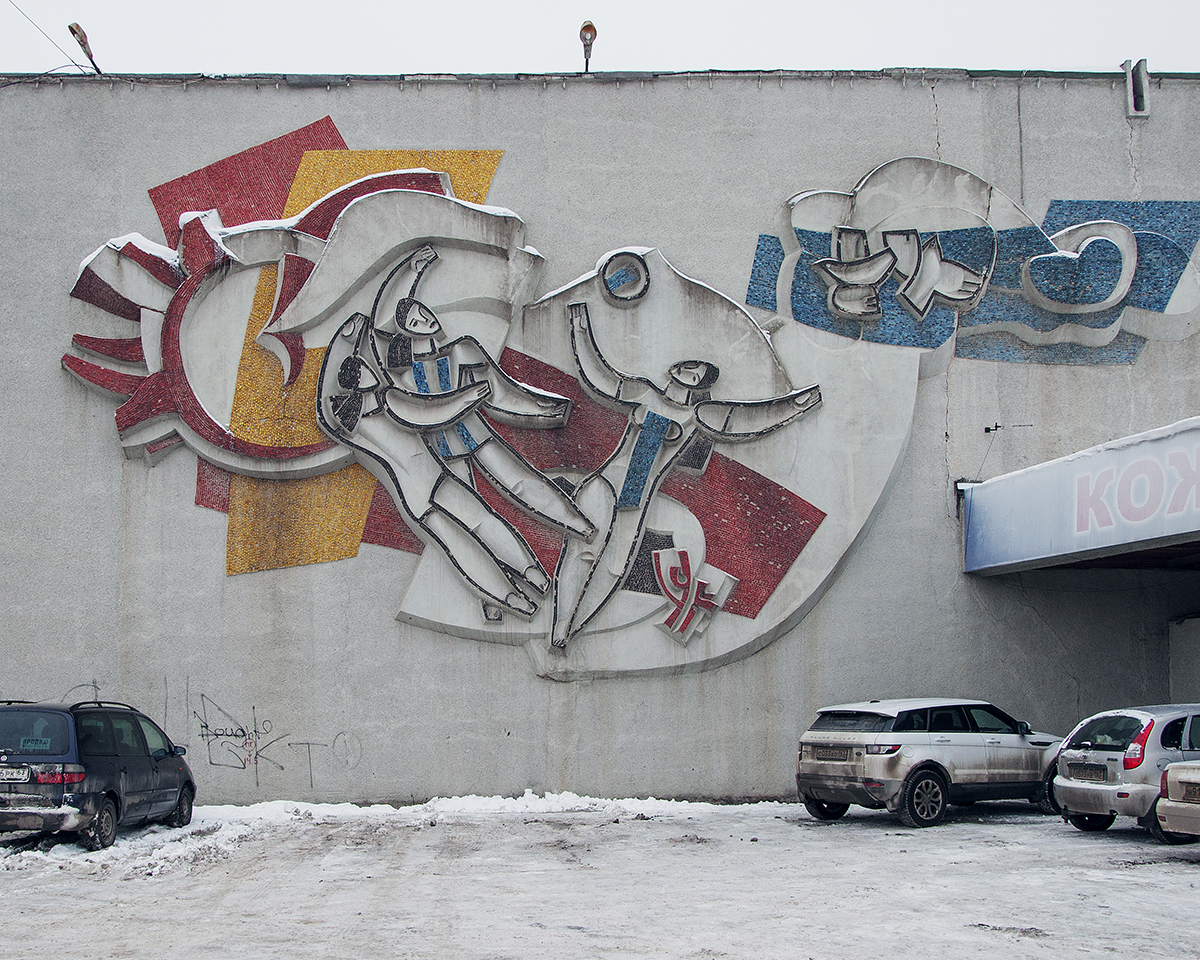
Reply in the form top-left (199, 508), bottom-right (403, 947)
top-left (62, 118), bottom-right (864, 679)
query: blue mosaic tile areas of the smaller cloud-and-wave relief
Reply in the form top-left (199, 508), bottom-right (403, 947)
top-left (746, 200), bottom-right (1200, 365)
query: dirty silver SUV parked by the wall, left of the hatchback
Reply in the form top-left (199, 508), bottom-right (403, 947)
top-left (796, 700), bottom-right (1062, 827)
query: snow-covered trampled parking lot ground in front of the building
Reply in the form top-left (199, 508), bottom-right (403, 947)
top-left (0, 794), bottom-right (1200, 960)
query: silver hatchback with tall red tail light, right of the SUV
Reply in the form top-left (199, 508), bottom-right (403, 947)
top-left (1054, 703), bottom-right (1200, 844)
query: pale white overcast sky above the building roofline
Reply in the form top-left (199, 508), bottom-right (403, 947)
top-left (0, 0), bottom-right (1200, 74)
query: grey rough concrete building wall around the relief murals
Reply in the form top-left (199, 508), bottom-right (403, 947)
top-left (0, 73), bottom-right (1200, 802)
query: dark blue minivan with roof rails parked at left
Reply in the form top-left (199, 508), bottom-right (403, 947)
top-left (0, 700), bottom-right (196, 850)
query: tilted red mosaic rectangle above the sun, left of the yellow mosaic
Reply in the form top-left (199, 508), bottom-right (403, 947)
top-left (149, 116), bottom-right (347, 247)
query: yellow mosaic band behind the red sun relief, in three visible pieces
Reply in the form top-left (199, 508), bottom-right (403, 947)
top-left (226, 150), bottom-right (503, 576)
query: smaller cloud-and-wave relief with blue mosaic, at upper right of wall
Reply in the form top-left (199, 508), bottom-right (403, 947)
top-left (746, 157), bottom-right (1200, 364)
